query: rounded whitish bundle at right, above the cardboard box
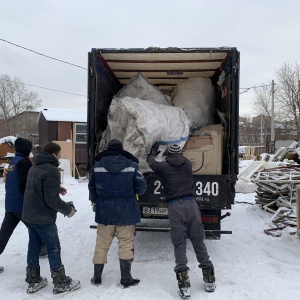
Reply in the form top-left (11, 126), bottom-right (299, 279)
top-left (172, 77), bottom-right (215, 129)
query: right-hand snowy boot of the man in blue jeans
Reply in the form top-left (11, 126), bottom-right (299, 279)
top-left (51, 265), bottom-right (81, 294)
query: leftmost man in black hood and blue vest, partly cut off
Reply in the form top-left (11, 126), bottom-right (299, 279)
top-left (0, 138), bottom-right (47, 273)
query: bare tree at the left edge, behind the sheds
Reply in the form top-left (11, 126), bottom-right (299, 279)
top-left (0, 74), bottom-right (41, 120)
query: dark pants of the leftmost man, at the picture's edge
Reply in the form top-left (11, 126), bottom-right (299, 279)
top-left (0, 211), bottom-right (27, 254)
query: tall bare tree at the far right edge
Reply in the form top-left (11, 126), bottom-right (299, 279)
top-left (275, 62), bottom-right (300, 139)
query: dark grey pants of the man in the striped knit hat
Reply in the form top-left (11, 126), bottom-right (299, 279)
top-left (168, 200), bottom-right (211, 272)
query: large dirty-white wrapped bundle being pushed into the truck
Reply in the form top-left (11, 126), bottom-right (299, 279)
top-left (99, 97), bottom-right (191, 173)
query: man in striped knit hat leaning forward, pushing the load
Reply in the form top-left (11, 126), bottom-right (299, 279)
top-left (147, 144), bottom-right (216, 298)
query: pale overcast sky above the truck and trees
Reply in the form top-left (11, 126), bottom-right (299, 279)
top-left (0, 0), bottom-right (300, 116)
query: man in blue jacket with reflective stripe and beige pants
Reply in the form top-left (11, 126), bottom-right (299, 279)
top-left (89, 139), bottom-right (147, 288)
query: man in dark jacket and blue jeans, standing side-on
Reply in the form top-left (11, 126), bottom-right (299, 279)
top-left (23, 142), bottom-right (80, 294)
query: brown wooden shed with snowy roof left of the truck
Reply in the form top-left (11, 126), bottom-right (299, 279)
top-left (38, 108), bottom-right (87, 176)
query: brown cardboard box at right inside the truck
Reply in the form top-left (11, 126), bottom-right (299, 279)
top-left (183, 124), bottom-right (223, 175)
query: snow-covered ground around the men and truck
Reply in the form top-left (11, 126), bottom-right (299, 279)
top-left (0, 177), bottom-right (300, 300)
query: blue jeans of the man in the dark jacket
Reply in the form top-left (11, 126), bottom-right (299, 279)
top-left (27, 223), bottom-right (62, 272)
